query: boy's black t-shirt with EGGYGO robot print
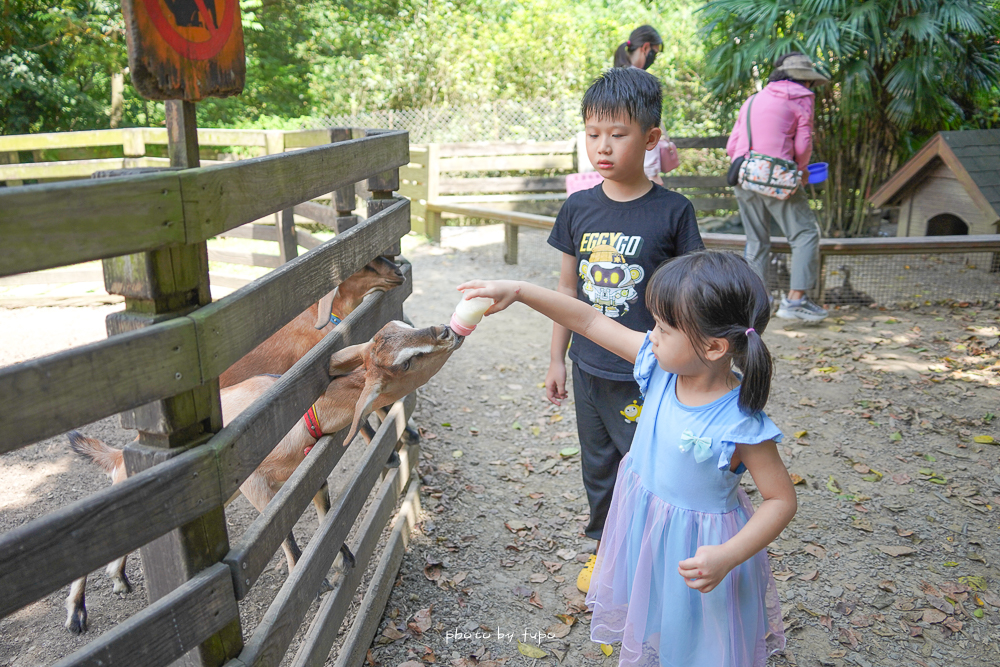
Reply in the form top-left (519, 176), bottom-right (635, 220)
top-left (549, 183), bottom-right (705, 380)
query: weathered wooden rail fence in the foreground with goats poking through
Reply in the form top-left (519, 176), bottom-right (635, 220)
top-left (0, 126), bottom-right (426, 667)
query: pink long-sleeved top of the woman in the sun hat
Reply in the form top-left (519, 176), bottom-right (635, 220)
top-left (726, 81), bottom-right (815, 171)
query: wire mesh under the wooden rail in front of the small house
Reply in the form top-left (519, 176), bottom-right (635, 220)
top-left (768, 252), bottom-right (1000, 307)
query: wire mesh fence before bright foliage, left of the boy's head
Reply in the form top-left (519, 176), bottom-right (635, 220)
top-left (310, 99), bottom-right (583, 144)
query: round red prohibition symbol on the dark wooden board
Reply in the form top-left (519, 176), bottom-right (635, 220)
top-left (142, 0), bottom-right (238, 60)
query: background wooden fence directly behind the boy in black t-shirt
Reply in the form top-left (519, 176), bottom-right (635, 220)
top-left (399, 133), bottom-right (737, 244)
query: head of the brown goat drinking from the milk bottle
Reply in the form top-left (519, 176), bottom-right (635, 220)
top-left (330, 321), bottom-right (464, 445)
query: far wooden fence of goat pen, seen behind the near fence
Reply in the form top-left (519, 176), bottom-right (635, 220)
top-left (0, 128), bottom-right (372, 289)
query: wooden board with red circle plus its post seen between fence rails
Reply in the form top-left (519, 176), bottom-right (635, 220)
top-left (104, 0), bottom-right (246, 667)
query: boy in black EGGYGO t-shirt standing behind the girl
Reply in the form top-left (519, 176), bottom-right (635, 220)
top-left (545, 68), bottom-right (704, 592)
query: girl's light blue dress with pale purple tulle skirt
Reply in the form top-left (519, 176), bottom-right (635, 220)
top-left (587, 334), bottom-right (785, 667)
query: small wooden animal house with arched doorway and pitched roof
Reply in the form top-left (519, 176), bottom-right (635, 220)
top-left (871, 130), bottom-right (1000, 236)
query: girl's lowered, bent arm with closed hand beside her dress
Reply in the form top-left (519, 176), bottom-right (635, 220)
top-left (677, 440), bottom-right (797, 593)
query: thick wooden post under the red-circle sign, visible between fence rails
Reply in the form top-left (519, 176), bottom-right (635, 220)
top-left (104, 100), bottom-right (243, 667)
